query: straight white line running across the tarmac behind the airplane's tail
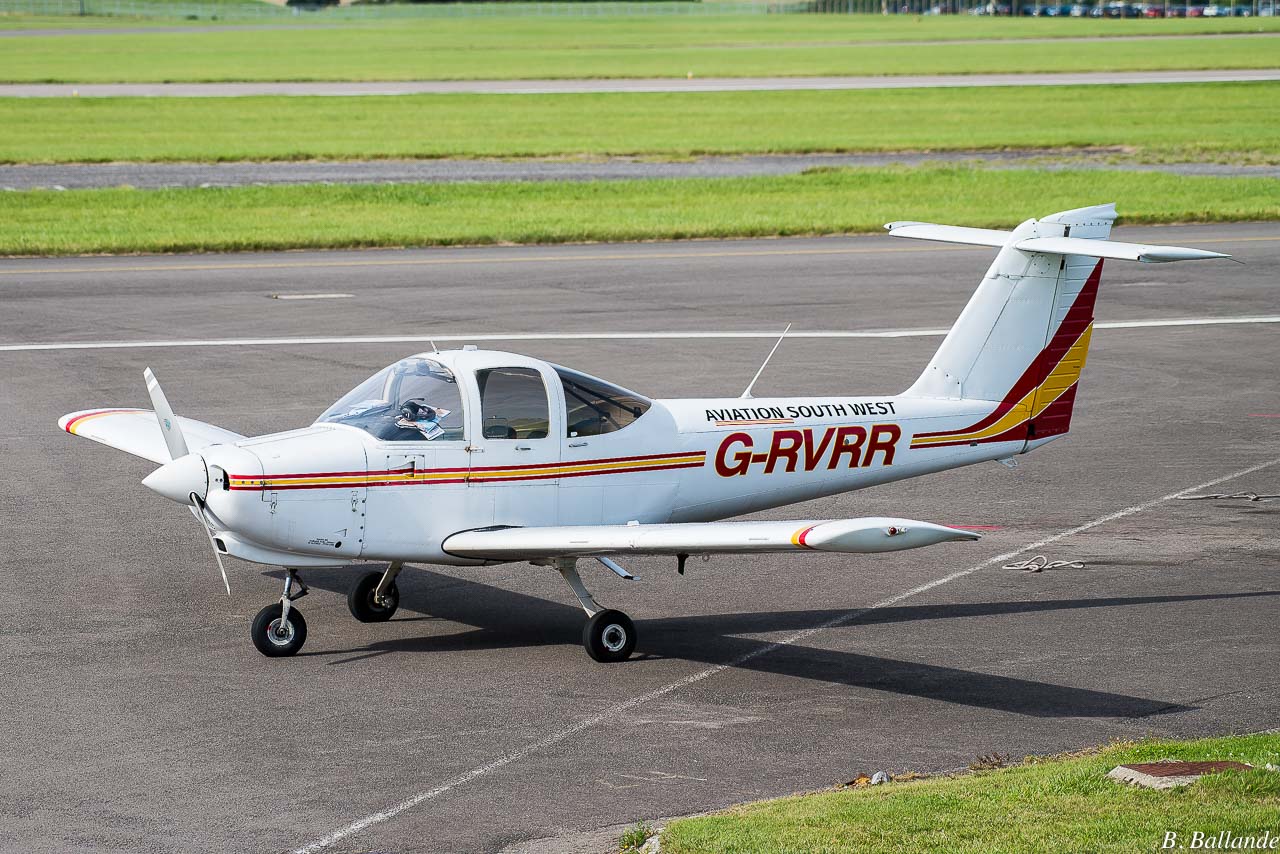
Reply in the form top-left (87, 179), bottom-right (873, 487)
top-left (0, 315), bottom-right (1280, 353)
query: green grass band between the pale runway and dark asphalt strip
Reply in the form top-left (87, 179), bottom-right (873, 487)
top-left (0, 83), bottom-right (1280, 163)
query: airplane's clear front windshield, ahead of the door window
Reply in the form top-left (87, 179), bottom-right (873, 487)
top-left (316, 356), bottom-right (463, 442)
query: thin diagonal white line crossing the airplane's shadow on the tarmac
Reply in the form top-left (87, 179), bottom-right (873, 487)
top-left (293, 457), bottom-right (1280, 854)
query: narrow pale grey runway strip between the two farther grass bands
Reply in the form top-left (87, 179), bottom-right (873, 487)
top-left (0, 68), bottom-right (1280, 97)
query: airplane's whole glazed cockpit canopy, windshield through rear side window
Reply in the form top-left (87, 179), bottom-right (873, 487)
top-left (316, 355), bottom-right (652, 442)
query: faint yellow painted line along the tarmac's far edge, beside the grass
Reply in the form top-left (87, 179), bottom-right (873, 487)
top-left (0, 234), bottom-right (1280, 275)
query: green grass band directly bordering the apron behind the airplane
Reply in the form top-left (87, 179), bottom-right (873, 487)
top-left (0, 168), bottom-right (1280, 255)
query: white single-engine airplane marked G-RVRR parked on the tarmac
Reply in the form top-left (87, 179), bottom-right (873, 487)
top-left (59, 205), bottom-right (1229, 662)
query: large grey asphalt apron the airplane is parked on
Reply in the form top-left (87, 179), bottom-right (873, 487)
top-left (0, 225), bottom-right (1280, 851)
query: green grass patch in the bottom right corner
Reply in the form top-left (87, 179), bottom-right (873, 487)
top-left (662, 734), bottom-right (1280, 854)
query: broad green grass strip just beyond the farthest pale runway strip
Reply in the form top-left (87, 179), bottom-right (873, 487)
top-left (0, 15), bottom-right (1280, 82)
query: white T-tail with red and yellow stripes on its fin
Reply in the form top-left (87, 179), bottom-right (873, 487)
top-left (886, 205), bottom-right (1230, 451)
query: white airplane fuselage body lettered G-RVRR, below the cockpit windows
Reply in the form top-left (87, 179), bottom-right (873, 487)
top-left (204, 386), bottom-right (1038, 566)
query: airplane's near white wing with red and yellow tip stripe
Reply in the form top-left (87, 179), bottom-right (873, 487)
top-left (443, 517), bottom-right (978, 561)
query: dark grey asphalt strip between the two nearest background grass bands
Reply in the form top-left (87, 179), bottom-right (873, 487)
top-left (0, 149), bottom-right (1280, 189)
